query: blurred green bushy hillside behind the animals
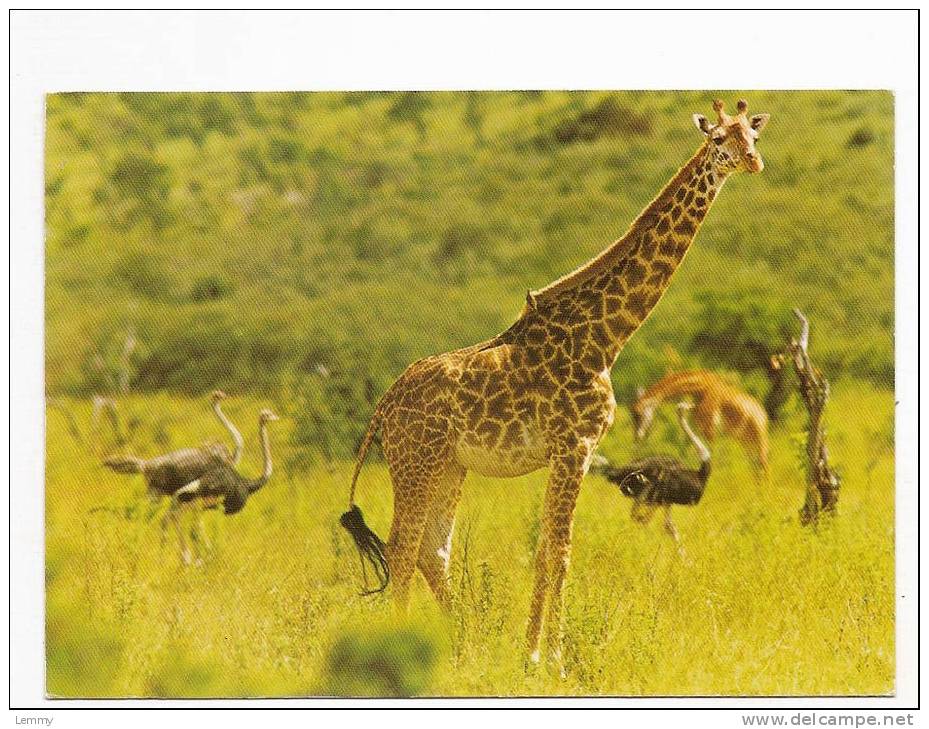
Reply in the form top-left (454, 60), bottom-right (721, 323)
top-left (46, 91), bottom-right (894, 450)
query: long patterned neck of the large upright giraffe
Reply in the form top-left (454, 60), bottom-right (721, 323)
top-left (529, 142), bottom-right (727, 367)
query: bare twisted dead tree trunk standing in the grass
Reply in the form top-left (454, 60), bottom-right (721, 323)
top-left (787, 309), bottom-right (840, 525)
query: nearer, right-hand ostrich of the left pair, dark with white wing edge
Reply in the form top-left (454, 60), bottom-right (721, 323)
top-left (171, 409), bottom-right (278, 563)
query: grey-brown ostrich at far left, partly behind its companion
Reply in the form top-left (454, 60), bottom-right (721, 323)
top-left (103, 390), bottom-right (245, 561)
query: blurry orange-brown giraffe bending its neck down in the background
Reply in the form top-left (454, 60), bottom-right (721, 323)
top-left (629, 370), bottom-right (768, 477)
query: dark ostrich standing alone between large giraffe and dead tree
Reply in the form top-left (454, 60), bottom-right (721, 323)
top-left (591, 402), bottom-right (710, 552)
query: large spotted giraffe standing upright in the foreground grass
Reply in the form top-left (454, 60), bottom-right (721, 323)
top-left (341, 100), bottom-right (769, 674)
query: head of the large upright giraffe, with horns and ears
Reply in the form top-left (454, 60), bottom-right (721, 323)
top-left (694, 99), bottom-right (770, 174)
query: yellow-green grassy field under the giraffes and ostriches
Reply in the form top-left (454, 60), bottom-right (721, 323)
top-left (46, 382), bottom-right (894, 696)
